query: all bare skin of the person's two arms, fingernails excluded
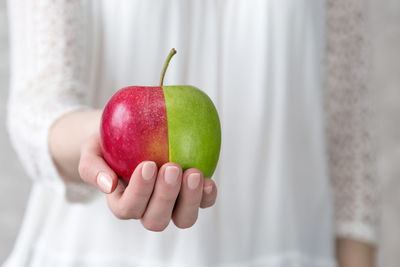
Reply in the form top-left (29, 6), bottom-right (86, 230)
top-left (49, 110), bottom-right (375, 262)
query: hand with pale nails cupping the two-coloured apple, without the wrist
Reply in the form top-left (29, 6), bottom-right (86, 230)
top-left (79, 134), bottom-right (217, 231)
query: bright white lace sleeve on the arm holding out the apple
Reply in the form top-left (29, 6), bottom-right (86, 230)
top-left (7, 0), bottom-right (94, 201)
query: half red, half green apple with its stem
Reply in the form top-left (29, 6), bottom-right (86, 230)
top-left (100, 49), bottom-right (221, 182)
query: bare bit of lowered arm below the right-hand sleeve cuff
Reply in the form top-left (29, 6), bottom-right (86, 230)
top-left (336, 238), bottom-right (375, 267)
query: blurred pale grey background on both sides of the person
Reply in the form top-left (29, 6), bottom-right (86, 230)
top-left (0, 0), bottom-right (400, 267)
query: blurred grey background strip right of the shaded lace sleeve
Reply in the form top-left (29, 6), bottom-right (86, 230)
top-left (369, 0), bottom-right (400, 267)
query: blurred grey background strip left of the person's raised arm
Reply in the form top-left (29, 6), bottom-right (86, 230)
top-left (0, 0), bottom-right (30, 263)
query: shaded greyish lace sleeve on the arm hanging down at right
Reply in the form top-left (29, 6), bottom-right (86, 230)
top-left (325, 0), bottom-right (376, 243)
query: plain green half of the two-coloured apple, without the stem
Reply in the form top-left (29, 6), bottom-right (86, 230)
top-left (162, 86), bottom-right (221, 177)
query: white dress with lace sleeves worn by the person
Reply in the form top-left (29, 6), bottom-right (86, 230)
top-left (5, 0), bottom-right (375, 267)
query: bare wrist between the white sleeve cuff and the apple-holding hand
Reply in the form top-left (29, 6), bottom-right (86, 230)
top-left (49, 110), bottom-right (101, 182)
